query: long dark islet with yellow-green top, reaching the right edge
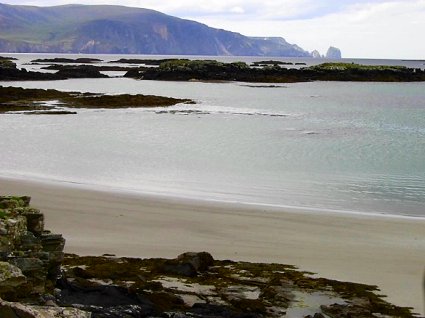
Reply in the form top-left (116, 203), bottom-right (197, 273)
top-left (125, 59), bottom-right (425, 83)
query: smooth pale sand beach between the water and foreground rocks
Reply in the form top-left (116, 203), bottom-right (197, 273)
top-left (0, 178), bottom-right (425, 313)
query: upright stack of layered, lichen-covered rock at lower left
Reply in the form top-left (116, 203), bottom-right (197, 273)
top-left (0, 197), bottom-right (65, 300)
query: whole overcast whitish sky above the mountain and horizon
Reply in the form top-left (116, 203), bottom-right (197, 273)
top-left (0, 0), bottom-right (425, 59)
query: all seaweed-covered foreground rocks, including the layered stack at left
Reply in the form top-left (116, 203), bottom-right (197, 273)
top-left (0, 196), bottom-right (415, 318)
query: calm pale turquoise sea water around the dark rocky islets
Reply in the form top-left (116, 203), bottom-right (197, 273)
top-left (0, 54), bottom-right (425, 217)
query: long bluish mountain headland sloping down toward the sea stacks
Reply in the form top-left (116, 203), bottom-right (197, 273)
top-left (0, 4), bottom-right (311, 57)
